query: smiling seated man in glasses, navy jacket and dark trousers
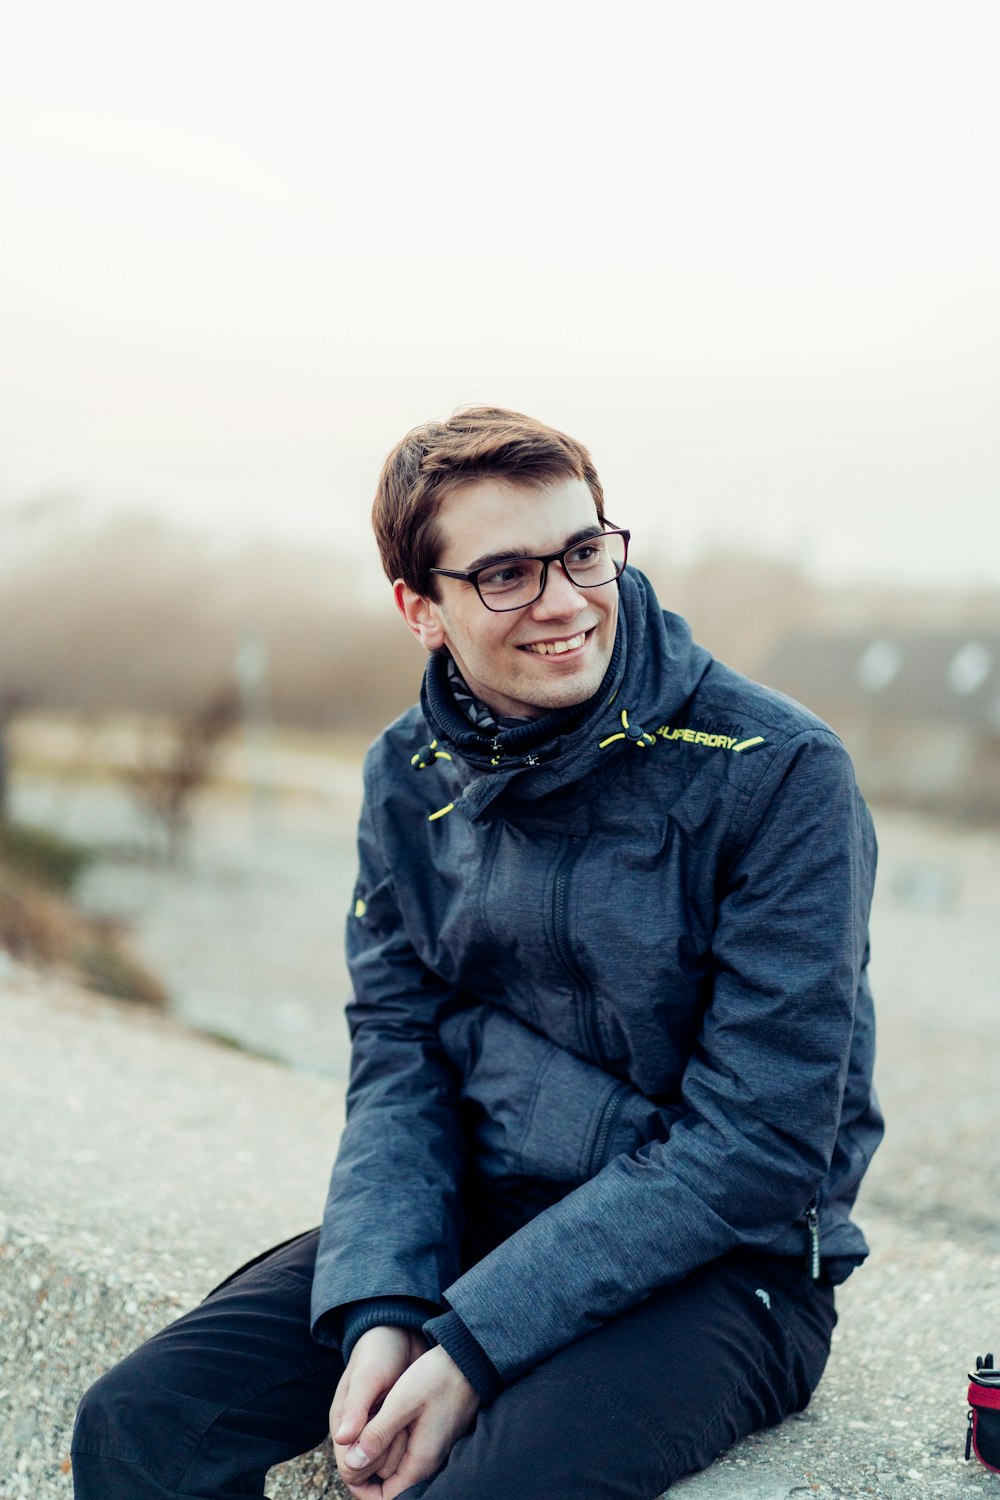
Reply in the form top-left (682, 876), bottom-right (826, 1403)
top-left (73, 408), bottom-right (882, 1500)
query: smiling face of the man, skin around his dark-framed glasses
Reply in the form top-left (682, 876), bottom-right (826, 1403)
top-left (396, 479), bottom-right (618, 719)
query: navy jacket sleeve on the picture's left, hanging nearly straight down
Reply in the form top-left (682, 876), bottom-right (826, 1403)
top-left (312, 756), bottom-right (463, 1337)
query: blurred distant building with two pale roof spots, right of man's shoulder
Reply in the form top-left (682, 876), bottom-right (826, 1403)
top-left (760, 630), bottom-right (1000, 822)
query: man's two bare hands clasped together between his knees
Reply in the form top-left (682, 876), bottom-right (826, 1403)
top-left (330, 1328), bottom-right (480, 1500)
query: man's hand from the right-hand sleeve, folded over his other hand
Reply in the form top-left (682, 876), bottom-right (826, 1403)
top-left (336, 1340), bottom-right (480, 1500)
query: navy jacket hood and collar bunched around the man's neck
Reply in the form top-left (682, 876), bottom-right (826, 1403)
top-left (412, 567), bottom-right (712, 819)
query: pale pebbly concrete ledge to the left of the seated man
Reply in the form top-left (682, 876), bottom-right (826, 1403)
top-left (0, 956), bottom-right (343, 1500)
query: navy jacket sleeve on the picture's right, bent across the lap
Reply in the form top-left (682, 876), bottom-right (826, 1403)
top-left (445, 731), bottom-right (874, 1380)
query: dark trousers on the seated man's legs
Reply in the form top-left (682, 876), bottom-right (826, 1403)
top-left (73, 1232), bottom-right (837, 1500)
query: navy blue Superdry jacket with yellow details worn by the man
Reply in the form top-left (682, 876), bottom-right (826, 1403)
top-left (313, 569), bottom-right (882, 1380)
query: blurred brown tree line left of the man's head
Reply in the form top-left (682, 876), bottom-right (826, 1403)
top-left (0, 516), bottom-right (421, 734)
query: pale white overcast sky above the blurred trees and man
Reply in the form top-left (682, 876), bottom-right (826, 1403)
top-left (0, 0), bottom-right (1000, 584)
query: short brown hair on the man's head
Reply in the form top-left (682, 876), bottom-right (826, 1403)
top-left (372, 407), bottom-right (604, 599)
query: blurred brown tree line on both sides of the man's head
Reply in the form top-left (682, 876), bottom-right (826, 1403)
top-left (0, 503), bottom-right (1000, 738)
